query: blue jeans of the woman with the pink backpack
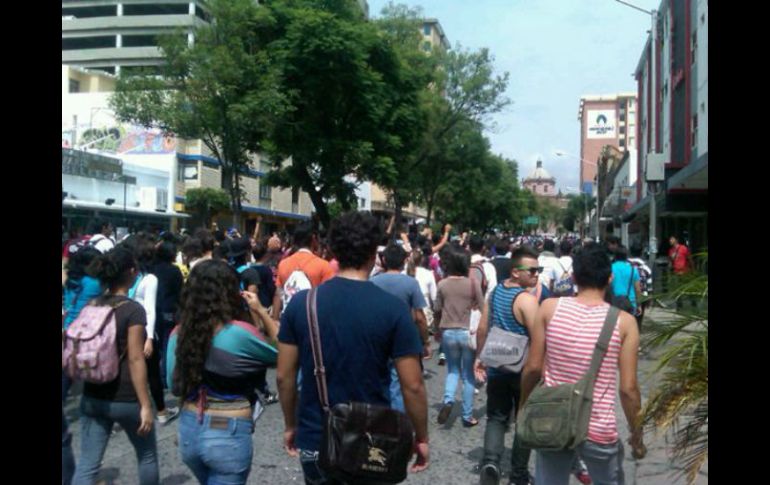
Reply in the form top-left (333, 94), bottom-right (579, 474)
top-left (73, 396), bottom-right (159, 485)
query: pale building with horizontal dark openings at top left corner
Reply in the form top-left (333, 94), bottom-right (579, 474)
top-left (61, 0), bottom-right (210, 74)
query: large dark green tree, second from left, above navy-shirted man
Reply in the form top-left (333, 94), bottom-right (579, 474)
top-left (258, 0), bottom-right (419, 225)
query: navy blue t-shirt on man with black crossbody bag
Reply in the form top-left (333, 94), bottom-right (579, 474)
top-left (278, 277), bottom-right (422, 451)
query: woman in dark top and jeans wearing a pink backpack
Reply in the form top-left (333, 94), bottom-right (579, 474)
top-left (73, 247), bottom-right (158, 485)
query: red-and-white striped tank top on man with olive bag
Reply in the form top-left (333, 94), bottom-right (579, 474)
top-left (544, 298), bottom-right (620, 444)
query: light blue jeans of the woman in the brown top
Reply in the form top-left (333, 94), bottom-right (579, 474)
top-left (441, 328), bottom-right (476, 421)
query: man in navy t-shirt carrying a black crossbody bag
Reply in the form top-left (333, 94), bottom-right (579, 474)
top-left (277, 212), bottom-right (429, 484)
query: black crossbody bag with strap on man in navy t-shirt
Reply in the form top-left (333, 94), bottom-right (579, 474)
top-left (306, 288), bottom-right (414, 485)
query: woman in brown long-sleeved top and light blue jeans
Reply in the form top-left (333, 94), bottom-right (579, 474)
top-left (433, 246), bottom-right (484, 427)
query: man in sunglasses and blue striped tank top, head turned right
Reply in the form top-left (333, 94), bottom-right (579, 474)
top-left (474, 246), bottom-right (542, 485)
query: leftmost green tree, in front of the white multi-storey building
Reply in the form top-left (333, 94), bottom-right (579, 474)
top-left (111, 0), bottom-right (287, 225)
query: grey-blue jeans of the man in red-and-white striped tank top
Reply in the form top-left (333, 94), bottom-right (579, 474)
top-left (535, 440), bottom-right (625, 485)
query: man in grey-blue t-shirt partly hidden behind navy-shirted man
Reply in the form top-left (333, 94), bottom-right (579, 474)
top-left (372, 244), bottom-right (431, 412)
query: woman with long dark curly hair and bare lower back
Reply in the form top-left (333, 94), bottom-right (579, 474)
top-left (166, 260), bottom-right (278, 484)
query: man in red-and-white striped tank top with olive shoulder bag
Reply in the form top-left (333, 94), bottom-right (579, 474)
top-left (522, 243), bottom-right (646, 485)
